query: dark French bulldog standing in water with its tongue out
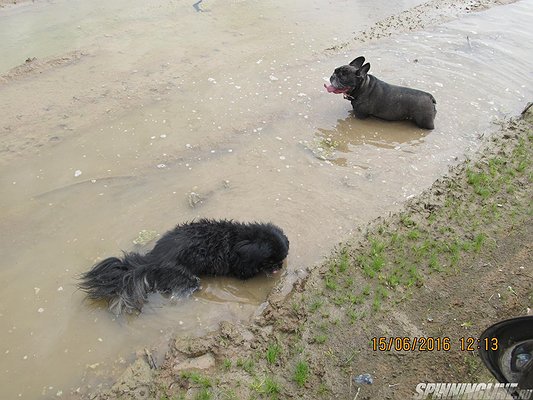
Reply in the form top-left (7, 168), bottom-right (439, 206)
top-left (324, 57), bottom-right (437, 129)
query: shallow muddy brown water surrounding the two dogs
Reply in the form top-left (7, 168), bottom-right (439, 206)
top-left (0, 0), bottom-right (533, 399)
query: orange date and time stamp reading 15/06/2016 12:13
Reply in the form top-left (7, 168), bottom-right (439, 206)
top-left (371, 336), bottom-right (499, 351)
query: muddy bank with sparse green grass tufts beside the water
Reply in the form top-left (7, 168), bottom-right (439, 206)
top-left (74, 110), bottom-right (533, 399)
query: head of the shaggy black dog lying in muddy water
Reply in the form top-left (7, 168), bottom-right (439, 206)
top-left (235, 224), bottom-right (289, 279)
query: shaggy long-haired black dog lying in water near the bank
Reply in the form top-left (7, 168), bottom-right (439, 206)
top-left (79, 219), bottom-right (289, 314)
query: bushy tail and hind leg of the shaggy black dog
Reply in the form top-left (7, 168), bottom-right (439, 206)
top-left (78, 253), bottom-right (199, 315)
